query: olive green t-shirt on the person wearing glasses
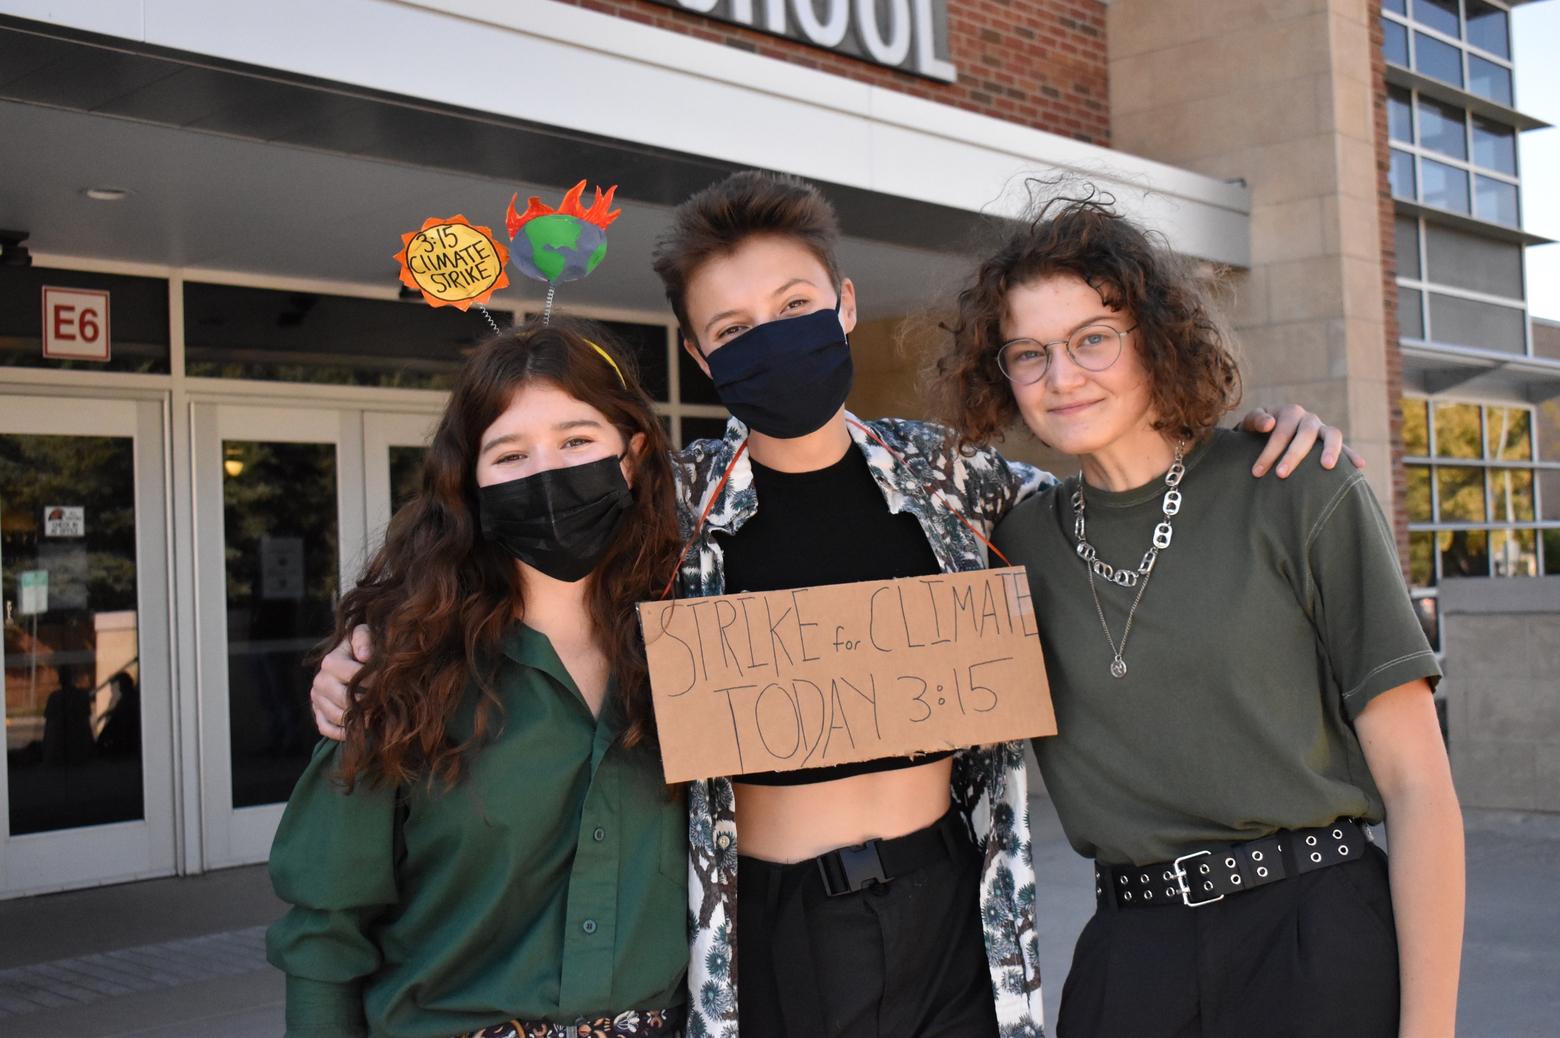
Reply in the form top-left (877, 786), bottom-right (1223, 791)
top-left (994, 431), bottom-right (1440, 865)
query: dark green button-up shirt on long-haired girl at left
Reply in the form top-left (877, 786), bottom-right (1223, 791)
top-left (267, 624), bottom-right (688, 1038)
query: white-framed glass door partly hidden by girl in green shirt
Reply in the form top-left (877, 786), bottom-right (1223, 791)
top-left (192, 404), bottom-right (363, 868)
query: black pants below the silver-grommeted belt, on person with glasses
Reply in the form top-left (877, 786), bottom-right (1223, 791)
top-left (1056, 848), bottom-right (1398, 1038)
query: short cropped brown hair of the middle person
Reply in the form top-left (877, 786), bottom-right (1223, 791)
top-left (655, 170), bottom-right (841, 342)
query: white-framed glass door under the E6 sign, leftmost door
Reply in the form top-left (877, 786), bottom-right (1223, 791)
top-left (0, 395), bottom-right (175, 898)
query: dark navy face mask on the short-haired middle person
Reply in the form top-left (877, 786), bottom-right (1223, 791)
top-left (707, 303), bottom-right (855, 440)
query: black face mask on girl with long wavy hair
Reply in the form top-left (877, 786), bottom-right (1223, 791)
top-left (477, 457), bottom-right (633, 584)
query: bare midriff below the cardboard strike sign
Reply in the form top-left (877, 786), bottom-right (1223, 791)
top-left (733, 759), bottom-right (953, 863)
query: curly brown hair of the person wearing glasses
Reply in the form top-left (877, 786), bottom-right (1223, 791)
top-left (925, 187), bottom-right (1240, 448)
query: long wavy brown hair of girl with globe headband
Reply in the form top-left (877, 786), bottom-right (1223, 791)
top-left (334, 317), bottom-right (680, 788)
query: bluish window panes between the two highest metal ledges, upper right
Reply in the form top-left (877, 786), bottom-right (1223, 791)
top-left (1387, 87), bottom-right (1521, 226)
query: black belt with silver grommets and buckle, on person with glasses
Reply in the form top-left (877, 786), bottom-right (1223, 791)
top-left (1094, 818), bottom-right (1374, 908)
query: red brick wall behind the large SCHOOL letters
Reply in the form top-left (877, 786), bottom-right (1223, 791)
top-left (558, 0), bottom-right (1111, 145)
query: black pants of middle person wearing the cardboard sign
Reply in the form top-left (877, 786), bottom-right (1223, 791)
top-left (736, 816), bottom-right (997, 1038)
